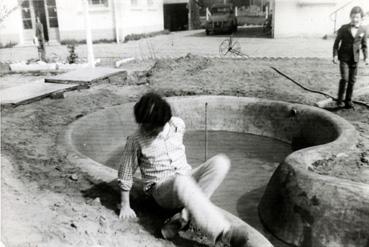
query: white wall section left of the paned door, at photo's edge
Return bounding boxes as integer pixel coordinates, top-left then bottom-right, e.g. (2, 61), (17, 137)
(0, 0), (23, 45)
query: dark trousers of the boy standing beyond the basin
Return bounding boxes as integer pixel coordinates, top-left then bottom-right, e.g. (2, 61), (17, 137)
(338, 61), (357, 103)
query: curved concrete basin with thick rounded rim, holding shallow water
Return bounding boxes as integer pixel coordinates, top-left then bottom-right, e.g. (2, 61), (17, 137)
(62, 96), (369, 247)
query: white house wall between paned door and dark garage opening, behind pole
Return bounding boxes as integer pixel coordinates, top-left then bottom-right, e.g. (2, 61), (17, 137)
(57, 0), (164, 40)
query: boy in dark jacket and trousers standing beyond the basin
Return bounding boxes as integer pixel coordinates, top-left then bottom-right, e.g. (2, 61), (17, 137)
(333, 7), (368, 108)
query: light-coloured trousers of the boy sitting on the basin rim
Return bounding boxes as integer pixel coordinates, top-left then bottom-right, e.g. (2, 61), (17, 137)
(152, 154), (230, 240)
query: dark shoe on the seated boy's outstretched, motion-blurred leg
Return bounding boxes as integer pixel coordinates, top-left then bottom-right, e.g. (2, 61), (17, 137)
(215, 226), (249, 247)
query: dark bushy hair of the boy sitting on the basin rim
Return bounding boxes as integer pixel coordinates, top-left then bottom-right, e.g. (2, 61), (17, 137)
(134, 93), (172, 131)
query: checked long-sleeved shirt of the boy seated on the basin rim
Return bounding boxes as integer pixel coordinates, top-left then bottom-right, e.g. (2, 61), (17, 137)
(118, 117), (191, 191)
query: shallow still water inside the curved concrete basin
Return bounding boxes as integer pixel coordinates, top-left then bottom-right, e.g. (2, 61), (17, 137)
(184, 131), (292, 247)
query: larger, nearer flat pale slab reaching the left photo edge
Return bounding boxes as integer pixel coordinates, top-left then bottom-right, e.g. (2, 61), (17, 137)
(0, 81), (79, 105)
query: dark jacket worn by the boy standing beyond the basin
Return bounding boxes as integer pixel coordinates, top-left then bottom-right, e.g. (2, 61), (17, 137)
(333, 24), (368, 63)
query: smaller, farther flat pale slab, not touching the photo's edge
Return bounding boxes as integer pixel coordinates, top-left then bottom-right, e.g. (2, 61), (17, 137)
(45, 67), (126, 84)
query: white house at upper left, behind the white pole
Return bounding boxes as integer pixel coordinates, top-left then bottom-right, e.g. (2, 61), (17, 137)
(0, 0), (164, 45)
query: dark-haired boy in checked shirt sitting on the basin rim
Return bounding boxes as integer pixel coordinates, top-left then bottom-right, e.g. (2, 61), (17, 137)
(118, 93), (248, 247)
